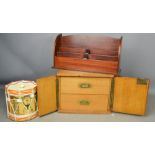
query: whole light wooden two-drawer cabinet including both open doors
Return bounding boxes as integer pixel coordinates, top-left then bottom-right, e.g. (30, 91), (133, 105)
(37, 70), (149, 116)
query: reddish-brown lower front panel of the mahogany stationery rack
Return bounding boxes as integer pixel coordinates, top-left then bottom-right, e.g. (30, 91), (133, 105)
(55, 56), (119, 75)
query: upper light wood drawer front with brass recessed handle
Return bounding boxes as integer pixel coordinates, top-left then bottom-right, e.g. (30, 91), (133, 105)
(60, 77), (111, 94)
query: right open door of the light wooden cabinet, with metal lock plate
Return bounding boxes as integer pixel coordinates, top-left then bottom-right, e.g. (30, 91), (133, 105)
(112, 77), (149, 115)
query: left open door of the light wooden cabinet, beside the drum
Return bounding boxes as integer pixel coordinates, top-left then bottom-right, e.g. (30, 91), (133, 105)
(37, 76), (57, 116)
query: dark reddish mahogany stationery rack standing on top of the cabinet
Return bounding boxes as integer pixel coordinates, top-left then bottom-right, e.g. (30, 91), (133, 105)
(54, 34), (122, 75)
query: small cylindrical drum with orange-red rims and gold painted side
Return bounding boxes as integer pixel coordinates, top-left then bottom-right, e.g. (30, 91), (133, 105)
(5, 81), (38, 121)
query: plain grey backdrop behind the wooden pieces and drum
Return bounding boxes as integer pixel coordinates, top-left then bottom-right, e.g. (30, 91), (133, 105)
(0, 33), (155, 93)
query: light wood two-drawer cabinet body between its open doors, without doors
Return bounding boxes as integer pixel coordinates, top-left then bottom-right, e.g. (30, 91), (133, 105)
(58, 71), (112, 113)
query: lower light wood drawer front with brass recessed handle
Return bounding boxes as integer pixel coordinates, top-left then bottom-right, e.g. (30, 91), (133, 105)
(59, 94), (109, 113)
